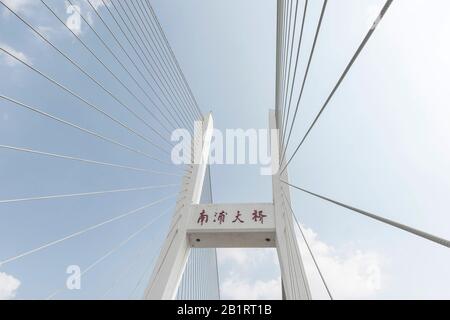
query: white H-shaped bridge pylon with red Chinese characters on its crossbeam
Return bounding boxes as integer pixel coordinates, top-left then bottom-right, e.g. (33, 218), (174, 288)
(144, 111), (311, 300)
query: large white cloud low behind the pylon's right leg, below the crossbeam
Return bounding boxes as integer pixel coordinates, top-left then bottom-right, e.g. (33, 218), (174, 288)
(218, 228), (385, 300)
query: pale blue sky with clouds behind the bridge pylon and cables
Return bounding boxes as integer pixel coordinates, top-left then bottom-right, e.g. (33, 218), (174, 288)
(0, 0), (450, 299)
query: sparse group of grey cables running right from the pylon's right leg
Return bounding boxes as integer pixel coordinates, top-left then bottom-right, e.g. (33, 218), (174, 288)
(270, 0), (450, 299)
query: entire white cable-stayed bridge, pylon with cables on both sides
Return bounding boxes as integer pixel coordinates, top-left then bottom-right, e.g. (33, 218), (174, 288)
(0, 0), (450, 300)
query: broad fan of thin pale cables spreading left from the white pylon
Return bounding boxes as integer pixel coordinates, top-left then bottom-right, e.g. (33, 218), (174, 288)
(0, 0), (204, 298)
